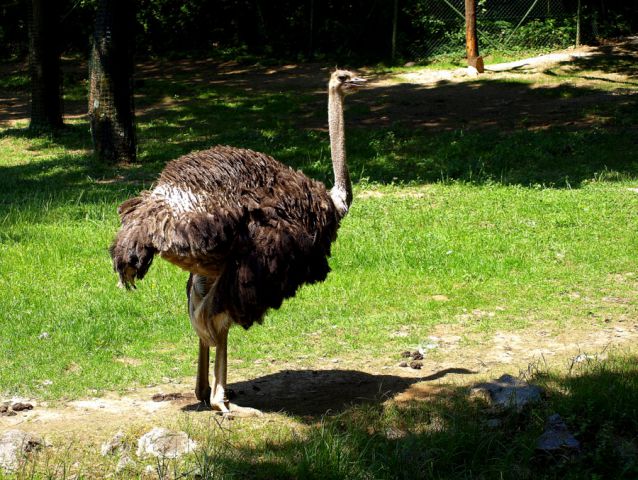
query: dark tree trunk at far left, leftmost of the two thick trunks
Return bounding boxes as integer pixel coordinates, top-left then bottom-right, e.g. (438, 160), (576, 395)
(29, 0), (62, 131)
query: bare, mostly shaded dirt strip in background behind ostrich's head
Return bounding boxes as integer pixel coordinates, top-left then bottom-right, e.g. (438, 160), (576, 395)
(0, 37), (638, 131)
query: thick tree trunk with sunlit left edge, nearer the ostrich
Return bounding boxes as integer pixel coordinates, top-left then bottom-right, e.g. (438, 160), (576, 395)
(89, 0), (135, 163)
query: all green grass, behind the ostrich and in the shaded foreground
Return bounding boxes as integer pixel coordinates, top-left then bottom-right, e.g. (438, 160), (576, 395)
(0, 43), (638, 478)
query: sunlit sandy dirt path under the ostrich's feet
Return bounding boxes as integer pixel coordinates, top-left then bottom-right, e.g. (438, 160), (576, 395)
(0, 319), (638, 444)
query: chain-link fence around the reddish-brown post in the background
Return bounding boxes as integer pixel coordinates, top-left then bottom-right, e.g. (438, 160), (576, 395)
(401, 0), (577, 61)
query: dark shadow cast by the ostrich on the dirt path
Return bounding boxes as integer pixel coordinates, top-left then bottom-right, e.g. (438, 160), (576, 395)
(182, 368), (476, 417)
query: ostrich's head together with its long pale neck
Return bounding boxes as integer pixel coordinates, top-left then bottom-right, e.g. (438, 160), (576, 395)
(328, 70), (365, 217)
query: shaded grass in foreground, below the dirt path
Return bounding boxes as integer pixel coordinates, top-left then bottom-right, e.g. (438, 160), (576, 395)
(6, 352), (638, 479)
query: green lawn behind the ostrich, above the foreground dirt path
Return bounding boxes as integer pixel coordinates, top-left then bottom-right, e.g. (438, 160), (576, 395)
(0, 50), (638, 398)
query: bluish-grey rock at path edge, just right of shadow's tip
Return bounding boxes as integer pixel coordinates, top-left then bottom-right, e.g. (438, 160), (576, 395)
(470, 374), (542, 412)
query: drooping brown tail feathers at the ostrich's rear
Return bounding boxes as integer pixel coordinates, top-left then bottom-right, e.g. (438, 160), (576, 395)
(109, 225), (156, 289)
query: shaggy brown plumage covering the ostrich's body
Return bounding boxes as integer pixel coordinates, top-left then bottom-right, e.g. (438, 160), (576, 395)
(111, 146), (339, 328)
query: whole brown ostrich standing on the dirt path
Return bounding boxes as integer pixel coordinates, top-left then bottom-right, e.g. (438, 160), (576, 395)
(109, 70), (365, 414)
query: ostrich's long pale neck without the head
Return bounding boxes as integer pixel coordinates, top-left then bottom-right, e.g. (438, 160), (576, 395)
(328, 88), (352, 215)
